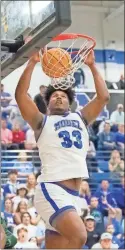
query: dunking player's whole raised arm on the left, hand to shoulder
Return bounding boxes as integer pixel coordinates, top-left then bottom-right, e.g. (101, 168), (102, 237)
(15, 53), (43, 130)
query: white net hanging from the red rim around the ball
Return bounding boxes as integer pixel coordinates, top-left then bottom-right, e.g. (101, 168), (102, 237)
(40, 34), (94, 90)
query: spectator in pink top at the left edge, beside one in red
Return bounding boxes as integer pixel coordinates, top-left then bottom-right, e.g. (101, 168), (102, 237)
(1, 120), (18, 149)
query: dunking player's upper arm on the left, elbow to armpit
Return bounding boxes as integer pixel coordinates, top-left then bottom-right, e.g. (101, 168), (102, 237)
(15, 93), (44, 131)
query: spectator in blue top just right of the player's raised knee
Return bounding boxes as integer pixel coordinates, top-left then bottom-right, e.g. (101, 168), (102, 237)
(89, 196), (105, 233)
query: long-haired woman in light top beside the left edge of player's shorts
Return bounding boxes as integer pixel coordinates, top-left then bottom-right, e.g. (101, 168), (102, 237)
(26, 174), (37, 204)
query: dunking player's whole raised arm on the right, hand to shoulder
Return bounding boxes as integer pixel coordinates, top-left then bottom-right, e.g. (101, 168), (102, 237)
(81, 50), (110, 124)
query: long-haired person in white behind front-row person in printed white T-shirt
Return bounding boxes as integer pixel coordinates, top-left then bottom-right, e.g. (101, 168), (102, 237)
(14, 212), (37, 240)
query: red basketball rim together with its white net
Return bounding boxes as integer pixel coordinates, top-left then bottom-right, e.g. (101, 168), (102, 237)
(40, 33), (96, 90)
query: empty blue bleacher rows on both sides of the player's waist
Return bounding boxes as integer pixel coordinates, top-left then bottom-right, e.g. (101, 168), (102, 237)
(1, 150), (120, 192)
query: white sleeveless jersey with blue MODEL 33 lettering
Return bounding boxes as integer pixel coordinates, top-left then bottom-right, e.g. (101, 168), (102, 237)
(37, 113), (89, 182)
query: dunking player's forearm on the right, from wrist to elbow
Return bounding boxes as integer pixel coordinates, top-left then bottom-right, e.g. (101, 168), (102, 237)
(90, 64), (110, 103)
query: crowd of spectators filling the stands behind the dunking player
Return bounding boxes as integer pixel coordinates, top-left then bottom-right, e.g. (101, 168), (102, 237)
(1, 84), (125, 249)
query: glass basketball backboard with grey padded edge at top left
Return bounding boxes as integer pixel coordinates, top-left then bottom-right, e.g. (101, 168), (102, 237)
(1, 0), (71, 79)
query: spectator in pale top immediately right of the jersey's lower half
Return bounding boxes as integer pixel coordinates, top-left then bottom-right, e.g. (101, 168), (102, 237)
(86, 141), (98, 173)
